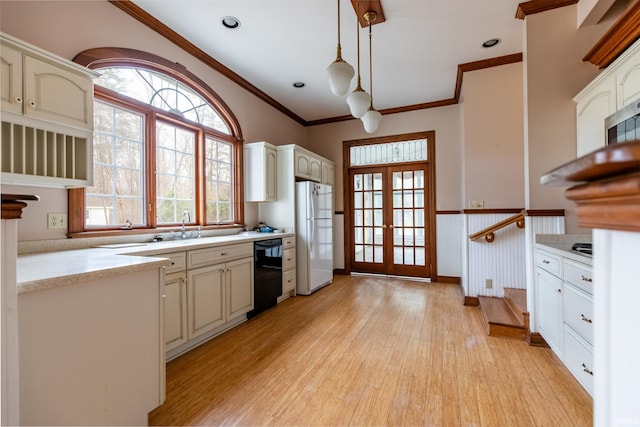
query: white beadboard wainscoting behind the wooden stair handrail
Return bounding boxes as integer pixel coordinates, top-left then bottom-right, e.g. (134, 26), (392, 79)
(463, 213), (526, 298)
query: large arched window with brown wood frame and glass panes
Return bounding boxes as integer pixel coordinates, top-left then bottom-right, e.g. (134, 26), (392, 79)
(69, 48), (243, 234)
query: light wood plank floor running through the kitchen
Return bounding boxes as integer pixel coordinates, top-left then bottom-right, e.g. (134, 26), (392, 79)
(149, 276), (593, 426)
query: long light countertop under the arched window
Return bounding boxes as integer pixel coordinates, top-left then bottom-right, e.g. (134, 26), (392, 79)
(16, 232), (293, 294)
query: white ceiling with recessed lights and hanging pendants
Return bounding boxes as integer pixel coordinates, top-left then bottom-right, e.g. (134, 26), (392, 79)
(133, 0), (524, 122)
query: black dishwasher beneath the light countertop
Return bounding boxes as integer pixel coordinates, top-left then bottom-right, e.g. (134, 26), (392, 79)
(247, 239), (282, 318)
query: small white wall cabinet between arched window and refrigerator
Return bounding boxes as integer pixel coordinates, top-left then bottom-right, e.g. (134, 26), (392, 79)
(244, 142), (278, 202)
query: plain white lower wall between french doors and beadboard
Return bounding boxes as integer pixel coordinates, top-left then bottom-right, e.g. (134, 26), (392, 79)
(436, 214), (462, 277)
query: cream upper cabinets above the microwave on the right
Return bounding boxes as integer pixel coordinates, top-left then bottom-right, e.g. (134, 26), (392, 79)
(573, 40), (640, 157)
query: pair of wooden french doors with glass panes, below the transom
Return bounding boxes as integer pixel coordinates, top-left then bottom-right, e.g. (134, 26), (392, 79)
(348, 162), (431, 277)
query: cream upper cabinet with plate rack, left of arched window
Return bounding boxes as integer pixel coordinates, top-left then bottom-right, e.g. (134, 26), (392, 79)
(0, 34), (96, 187)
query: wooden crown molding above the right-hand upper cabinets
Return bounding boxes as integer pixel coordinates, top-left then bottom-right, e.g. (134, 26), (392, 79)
(582, 0), (640, 69)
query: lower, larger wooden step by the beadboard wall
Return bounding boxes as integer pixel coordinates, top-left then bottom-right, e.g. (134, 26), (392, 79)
(478, 296), (527, 341)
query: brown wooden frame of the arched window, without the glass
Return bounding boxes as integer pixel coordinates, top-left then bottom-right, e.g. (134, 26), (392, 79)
(68, 48), (244, 241)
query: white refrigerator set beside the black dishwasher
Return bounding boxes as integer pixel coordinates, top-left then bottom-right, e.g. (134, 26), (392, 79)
(296, 181), (333, 295)
